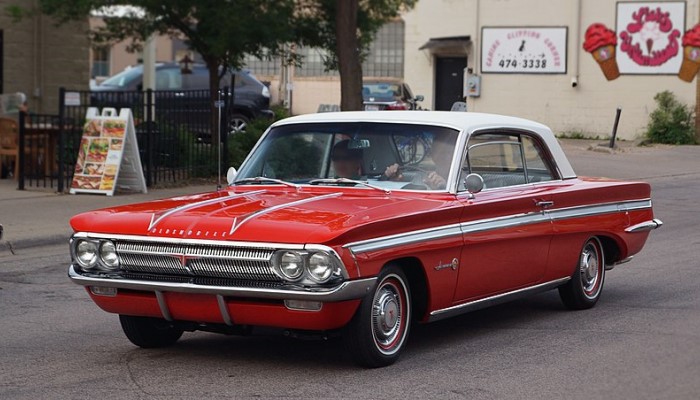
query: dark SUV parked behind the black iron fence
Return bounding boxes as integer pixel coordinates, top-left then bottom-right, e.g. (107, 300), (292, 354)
(92, 63), (273, 134)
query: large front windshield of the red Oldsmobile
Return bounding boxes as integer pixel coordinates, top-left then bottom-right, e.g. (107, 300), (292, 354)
(236, 122), (458, 190)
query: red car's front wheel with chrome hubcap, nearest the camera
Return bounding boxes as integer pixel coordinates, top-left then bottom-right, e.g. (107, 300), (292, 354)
(343, 266), (411, 368)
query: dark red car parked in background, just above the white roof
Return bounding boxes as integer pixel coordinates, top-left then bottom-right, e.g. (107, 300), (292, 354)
(362, 80), (423, 111)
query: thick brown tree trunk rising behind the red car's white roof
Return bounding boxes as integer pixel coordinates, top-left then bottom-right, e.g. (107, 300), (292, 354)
(335, 0), (362, 111)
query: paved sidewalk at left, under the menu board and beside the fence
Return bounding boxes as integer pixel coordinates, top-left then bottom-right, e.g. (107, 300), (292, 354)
(0, 179), (216, 251)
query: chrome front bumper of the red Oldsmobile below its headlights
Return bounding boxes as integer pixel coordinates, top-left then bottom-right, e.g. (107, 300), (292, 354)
(68, 265), (377, 302)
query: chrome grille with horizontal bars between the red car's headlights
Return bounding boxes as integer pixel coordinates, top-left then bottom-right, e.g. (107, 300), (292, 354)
(115, 240), (280, 281)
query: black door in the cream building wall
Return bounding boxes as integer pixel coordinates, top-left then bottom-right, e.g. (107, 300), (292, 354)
(435, 57), (467, 111)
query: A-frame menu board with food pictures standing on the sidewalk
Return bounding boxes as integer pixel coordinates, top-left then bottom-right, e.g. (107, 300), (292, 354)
(70, 108), (146, 196)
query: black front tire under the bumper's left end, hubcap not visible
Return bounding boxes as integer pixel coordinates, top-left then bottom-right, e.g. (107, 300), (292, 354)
(119, 315), (183, 349)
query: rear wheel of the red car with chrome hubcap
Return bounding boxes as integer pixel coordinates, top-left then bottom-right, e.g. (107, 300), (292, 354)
(559, 237), (605, 310)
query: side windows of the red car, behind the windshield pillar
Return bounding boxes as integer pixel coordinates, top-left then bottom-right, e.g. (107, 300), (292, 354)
(460, 133), (554, 189)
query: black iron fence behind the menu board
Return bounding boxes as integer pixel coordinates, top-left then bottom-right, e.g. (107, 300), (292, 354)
(18, 88), (232, 192)
